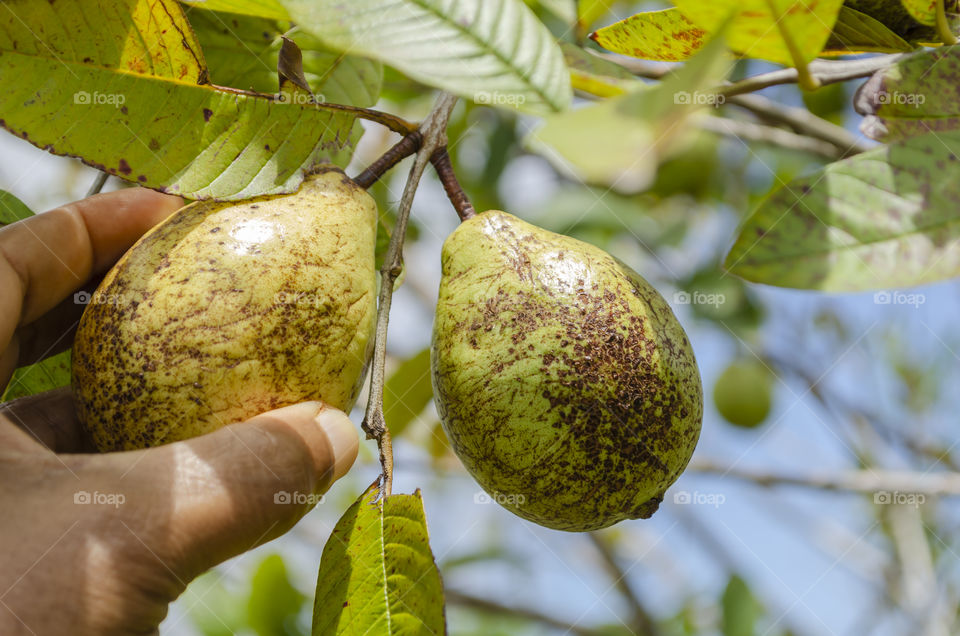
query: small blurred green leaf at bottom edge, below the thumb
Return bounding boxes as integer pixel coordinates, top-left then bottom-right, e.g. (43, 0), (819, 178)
(247, 554), (307, 636)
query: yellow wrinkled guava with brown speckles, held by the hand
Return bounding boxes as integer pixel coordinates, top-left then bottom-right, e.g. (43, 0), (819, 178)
(73, 167), (377, 451)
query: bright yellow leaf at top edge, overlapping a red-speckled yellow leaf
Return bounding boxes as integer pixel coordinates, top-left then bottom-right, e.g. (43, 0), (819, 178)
(674, 0), (843, 66)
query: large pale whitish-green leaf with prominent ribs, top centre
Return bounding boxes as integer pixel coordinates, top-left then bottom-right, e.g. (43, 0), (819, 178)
(281, 0), (571, 110)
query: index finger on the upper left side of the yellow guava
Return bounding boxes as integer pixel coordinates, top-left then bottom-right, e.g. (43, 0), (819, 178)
(0, 188), (183, 350)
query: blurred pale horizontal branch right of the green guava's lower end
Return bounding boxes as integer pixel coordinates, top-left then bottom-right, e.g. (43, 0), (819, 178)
(687, 460), (960, 497)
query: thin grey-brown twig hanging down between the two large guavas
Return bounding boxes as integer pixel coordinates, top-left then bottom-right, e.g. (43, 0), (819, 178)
(363, 92), (457, 497)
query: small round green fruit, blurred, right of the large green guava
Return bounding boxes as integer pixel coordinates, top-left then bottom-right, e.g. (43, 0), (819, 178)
(713, 358), (773, 428)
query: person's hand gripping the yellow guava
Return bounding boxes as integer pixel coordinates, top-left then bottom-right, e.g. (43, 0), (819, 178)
(0, 188), (358, 635)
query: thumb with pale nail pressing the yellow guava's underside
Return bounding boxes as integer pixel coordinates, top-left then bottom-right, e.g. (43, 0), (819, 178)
(113, 402), (359, 580)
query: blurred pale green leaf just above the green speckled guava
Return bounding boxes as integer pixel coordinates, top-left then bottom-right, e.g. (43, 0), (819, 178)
(526, 31), (730, 193)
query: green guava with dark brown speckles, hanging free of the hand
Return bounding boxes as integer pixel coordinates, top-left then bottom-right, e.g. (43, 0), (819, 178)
(431, 211), (703, 531)
